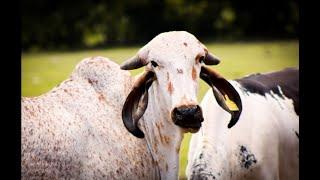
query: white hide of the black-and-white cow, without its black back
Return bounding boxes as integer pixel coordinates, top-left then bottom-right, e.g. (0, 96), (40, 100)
(186, 81), (299, 180)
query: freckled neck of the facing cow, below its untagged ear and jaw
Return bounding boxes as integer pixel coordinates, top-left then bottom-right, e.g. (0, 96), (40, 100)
(141, 83), (183, 180)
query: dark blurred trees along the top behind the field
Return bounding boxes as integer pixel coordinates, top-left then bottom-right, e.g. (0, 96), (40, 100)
(21, 0), (299, 50)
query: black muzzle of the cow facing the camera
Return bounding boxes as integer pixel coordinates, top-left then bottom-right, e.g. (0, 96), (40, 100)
(171, 105), (203, 130)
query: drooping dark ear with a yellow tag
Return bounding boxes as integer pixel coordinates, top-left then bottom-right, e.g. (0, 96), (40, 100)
(200, 66), (242, 128)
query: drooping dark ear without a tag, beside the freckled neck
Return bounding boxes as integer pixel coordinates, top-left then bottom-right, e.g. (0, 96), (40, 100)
(122, 71), (155, 138)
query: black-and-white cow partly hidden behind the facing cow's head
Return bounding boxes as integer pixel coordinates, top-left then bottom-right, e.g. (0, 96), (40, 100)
(186, 68), (299, 180)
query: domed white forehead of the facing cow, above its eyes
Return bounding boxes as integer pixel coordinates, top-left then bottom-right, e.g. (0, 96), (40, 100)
(147, 31), (205, 63)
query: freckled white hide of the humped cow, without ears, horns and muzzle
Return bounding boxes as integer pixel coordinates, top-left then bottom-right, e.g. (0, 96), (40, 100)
(21, 31), (212, 180)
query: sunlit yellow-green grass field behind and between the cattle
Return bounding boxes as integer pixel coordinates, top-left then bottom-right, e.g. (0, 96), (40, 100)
(21, 41), (299, 179)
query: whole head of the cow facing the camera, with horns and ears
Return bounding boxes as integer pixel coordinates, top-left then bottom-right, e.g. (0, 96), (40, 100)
(121, 32), (241, 138)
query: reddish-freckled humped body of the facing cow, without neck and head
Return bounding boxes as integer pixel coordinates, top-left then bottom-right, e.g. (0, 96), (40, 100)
(21, 57), (156, 179)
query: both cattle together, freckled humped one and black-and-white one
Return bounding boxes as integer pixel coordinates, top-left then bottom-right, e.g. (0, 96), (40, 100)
(21, 31), (299, 180)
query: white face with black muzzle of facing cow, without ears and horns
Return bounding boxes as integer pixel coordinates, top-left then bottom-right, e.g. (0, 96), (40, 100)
(146, 33), (211, 131)
